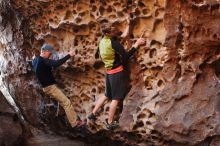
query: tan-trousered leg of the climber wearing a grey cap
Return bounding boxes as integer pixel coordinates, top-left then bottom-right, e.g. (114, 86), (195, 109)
(44, 85), (77, 127)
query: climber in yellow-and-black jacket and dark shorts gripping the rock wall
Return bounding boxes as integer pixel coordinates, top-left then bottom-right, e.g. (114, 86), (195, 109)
(88, 24), (145, 129)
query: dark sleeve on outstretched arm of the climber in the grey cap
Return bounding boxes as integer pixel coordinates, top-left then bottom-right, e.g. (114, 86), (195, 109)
(44, 54), (71, 67)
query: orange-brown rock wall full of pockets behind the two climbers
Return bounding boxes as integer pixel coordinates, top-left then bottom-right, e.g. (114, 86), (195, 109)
(0, 0), (220, 145)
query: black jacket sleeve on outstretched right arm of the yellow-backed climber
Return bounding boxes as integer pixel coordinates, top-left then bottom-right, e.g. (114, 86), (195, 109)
(111, 39), (136, 61)
